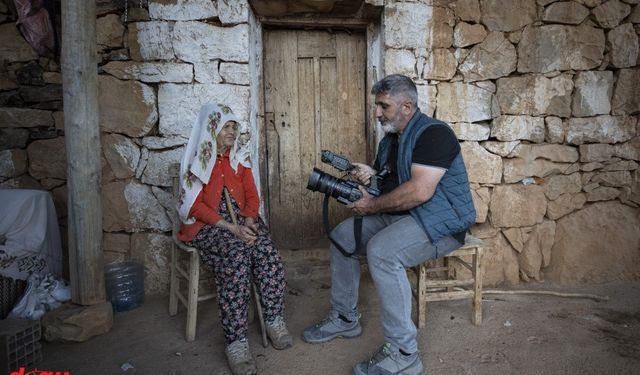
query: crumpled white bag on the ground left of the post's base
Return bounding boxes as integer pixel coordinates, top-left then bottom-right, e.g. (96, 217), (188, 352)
(9, 273), (71, 320)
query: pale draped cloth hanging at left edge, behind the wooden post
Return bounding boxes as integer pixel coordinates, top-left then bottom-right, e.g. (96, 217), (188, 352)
(0, 189), (62, 280)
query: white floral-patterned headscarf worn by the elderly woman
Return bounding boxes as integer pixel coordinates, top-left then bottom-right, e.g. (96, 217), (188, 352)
(177, 103), (251, 224)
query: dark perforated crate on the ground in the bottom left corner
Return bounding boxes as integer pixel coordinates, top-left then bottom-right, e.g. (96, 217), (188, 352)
(0, 319), (42, 375)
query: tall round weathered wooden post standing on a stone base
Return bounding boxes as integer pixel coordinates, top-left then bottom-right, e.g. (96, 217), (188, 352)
(61, 0), (105, 305)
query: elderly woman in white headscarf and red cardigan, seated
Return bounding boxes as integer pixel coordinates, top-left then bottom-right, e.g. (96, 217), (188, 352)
(178, 104), (292, 375)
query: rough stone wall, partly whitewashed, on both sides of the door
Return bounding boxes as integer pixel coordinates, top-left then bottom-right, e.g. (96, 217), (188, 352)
(0, 0), (640, 293)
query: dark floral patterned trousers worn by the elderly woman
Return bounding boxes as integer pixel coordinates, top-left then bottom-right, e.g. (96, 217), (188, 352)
(192, 196), (285, 345)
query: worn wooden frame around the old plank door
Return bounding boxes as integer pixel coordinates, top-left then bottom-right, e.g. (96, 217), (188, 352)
(249, 17), (384, 222)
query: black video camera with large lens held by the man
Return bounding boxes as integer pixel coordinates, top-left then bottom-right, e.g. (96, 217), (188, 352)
(307, 150), (389, 204)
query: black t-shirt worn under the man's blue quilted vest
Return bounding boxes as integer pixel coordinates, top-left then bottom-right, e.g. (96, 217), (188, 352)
(373, 125), (465, 243)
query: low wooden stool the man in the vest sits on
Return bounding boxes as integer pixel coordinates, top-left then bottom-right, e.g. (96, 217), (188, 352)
(413, 235), (484, 328)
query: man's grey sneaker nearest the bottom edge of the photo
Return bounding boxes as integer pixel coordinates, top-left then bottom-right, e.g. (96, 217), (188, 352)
(352, 343), (422, 375)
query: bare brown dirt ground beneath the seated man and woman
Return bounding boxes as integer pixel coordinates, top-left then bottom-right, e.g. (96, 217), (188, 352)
(38, 274), (640, 375)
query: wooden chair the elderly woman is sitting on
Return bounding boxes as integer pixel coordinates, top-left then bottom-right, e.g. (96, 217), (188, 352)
(169, 164), (269, 348)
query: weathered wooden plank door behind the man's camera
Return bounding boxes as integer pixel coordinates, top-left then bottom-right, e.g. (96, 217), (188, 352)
(264, 30), (367, 249)
